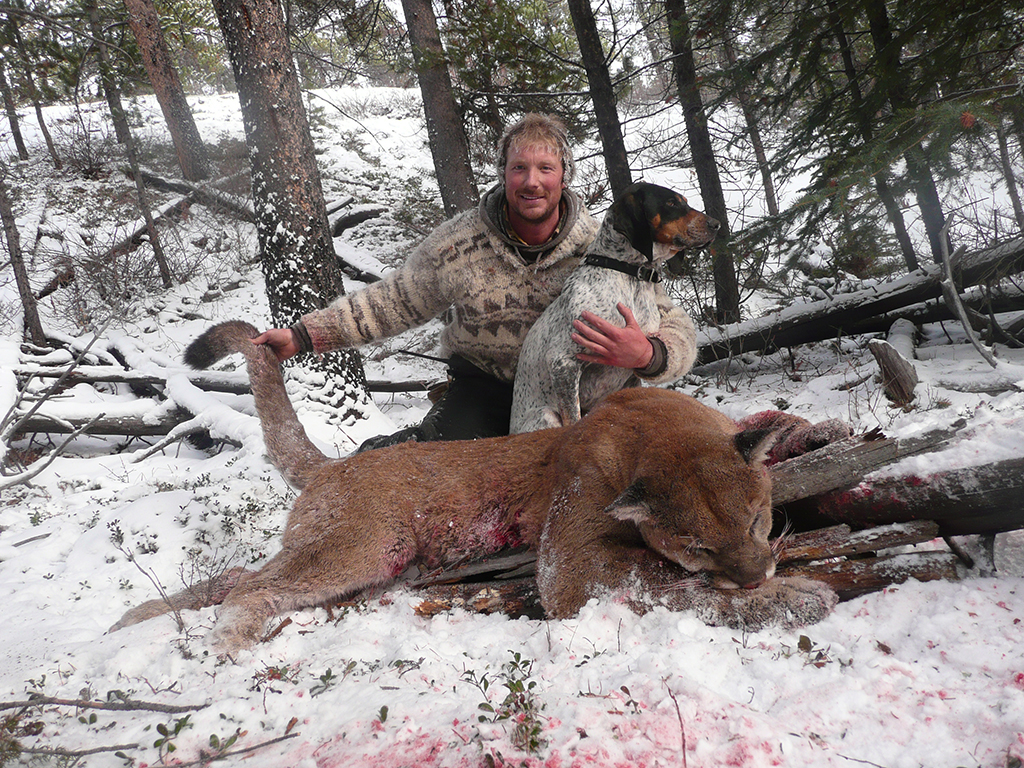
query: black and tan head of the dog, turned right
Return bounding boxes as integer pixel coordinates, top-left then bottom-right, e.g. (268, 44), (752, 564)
(607, 181), (721, 261)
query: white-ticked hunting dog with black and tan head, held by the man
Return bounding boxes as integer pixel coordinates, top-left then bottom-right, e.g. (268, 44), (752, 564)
(510, 181), (721, 434)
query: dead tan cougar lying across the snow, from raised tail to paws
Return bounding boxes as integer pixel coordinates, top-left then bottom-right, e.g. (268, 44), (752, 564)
(117, 322), (836, 651)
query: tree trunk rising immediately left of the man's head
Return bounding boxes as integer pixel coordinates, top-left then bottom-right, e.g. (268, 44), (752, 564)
(401, 0), (479, 216)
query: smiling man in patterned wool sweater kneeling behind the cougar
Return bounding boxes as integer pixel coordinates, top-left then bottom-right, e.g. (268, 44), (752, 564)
(253, 114), (696, 451)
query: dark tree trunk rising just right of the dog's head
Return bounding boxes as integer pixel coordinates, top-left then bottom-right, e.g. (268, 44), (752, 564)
(665, 0), (739, 323)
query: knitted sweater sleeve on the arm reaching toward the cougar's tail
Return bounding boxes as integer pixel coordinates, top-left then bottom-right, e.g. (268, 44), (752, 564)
(302, 225), (452, 353)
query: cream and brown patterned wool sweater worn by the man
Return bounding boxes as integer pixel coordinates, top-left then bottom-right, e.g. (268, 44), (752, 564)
(302, 185), (696, 382)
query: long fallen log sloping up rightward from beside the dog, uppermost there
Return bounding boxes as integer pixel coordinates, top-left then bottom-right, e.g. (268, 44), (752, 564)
(698, 238), (1024, 365)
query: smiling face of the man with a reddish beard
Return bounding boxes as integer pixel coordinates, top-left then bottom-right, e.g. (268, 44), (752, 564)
(505, 146), (563, 236)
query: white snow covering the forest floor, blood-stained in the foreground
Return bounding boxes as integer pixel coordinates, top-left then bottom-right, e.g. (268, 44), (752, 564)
(0, 89), (1024, 768)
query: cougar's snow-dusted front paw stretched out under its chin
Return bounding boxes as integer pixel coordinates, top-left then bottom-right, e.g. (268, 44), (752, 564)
(695, 578), (839, 632)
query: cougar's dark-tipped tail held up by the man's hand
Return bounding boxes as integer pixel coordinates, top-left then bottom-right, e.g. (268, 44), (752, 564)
(184, 321), (330, 490)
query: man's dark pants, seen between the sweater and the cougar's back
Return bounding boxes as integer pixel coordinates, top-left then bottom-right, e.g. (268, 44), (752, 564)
(356, 354), (512, 453)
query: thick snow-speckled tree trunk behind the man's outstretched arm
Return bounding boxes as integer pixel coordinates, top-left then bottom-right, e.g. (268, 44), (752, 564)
(213, 0), (367, 419)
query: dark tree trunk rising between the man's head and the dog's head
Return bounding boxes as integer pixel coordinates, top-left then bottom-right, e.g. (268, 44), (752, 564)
(568, 0), (632, 199)
